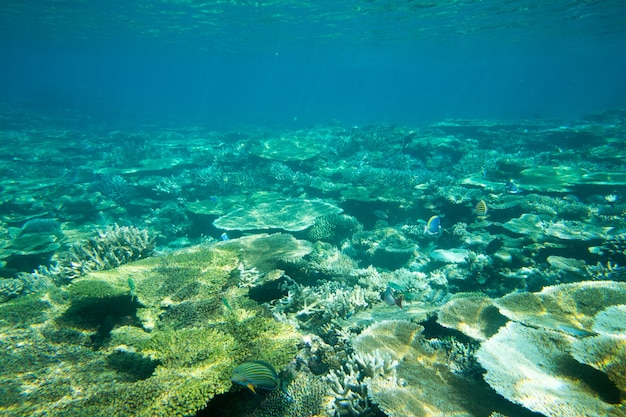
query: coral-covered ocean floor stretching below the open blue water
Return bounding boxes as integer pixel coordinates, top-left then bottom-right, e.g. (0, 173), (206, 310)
(0, 110), (626, 417)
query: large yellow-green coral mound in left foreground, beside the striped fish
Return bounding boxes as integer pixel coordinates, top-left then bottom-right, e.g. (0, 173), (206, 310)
(0, 240), (299, 416)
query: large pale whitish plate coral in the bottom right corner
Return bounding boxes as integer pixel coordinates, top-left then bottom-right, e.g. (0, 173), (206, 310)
(477, 322), (624, 417)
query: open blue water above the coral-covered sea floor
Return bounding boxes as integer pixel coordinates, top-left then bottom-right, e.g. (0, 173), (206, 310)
(0, 0), (626, 128)
